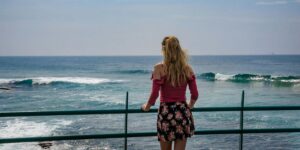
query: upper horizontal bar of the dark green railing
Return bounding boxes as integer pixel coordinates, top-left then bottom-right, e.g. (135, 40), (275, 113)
(0, 106), (300, 117)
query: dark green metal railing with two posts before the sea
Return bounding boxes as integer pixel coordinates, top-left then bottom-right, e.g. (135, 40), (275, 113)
(0, 91), (300, 150)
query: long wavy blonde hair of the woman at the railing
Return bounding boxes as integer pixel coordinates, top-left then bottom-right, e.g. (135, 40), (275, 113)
(162, 36), (191, 87)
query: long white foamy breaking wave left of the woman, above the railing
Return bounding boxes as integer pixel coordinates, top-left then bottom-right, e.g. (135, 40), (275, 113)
(0, 77), (126, 85)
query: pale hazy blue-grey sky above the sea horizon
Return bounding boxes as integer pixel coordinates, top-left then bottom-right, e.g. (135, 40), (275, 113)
(0, 0), (300, 56)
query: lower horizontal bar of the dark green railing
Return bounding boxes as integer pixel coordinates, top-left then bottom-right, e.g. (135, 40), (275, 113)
(0, 128), (300, 144)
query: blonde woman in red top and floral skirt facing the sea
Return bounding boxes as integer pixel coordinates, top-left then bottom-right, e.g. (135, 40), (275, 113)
(142, 36), (198, 150)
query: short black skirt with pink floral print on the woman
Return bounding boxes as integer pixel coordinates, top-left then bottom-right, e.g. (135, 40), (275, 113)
(157, 101), (195, 142)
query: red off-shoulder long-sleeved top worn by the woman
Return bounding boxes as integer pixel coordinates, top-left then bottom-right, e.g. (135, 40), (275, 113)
(148, 63), (198, 105)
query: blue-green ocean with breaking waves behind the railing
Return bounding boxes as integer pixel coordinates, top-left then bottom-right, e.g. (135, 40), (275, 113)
(0, 55), (300, 150)
